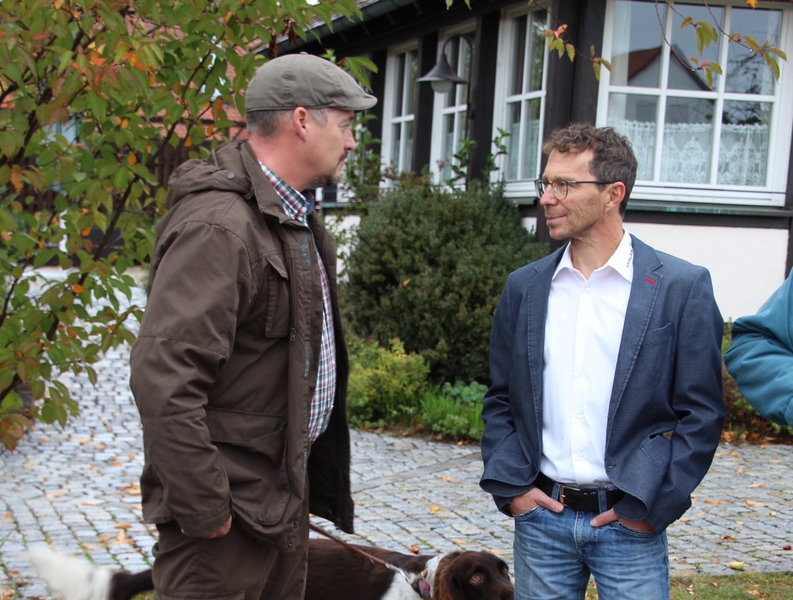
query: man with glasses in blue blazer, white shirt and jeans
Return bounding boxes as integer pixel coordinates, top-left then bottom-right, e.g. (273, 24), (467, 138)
(480, 124), (725, 600)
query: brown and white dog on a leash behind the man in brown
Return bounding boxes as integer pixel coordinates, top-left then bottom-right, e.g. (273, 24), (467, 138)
(29, 538), (513, 600)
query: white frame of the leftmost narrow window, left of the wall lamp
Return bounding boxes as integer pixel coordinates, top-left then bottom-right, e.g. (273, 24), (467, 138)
(381, 40), (420, 172)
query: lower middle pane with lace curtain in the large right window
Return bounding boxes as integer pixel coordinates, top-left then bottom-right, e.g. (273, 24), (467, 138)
(661, 98), (714, 183)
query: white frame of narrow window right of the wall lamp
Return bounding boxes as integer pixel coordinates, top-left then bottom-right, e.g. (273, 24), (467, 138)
(490, 7), (549, 198)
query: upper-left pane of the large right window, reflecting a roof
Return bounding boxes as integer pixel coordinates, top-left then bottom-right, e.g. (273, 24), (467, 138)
(611, 0), (666, 87)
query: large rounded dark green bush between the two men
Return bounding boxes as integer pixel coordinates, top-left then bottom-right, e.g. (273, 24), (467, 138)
(342, 179), (547, 381)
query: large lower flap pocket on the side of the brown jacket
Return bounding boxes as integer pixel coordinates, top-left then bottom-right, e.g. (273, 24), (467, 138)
(206, 407), (292, 525)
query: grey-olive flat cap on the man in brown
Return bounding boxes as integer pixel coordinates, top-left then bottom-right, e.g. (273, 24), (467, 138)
(245, 52), (377, 112)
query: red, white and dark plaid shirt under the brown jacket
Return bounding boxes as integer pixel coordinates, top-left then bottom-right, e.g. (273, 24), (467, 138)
(259, 162), (336, 444)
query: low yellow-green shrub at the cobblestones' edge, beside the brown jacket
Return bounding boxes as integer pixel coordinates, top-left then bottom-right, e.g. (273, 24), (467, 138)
(347, 337), (429, 427)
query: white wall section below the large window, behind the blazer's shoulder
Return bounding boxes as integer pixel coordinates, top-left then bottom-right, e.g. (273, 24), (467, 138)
(625, 223), (788, 321)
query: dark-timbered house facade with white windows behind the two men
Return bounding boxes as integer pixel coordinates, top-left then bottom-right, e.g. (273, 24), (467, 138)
(281, 0), (793, 320)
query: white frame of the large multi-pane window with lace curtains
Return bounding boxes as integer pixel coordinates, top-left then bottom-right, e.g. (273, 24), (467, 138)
(597, 0), (793, 206)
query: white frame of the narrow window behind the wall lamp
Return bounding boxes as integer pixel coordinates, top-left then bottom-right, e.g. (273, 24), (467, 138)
(430, 21), (476, 187)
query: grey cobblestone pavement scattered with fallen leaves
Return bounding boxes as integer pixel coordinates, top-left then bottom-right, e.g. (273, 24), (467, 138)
(0, 272), (793, 599)
